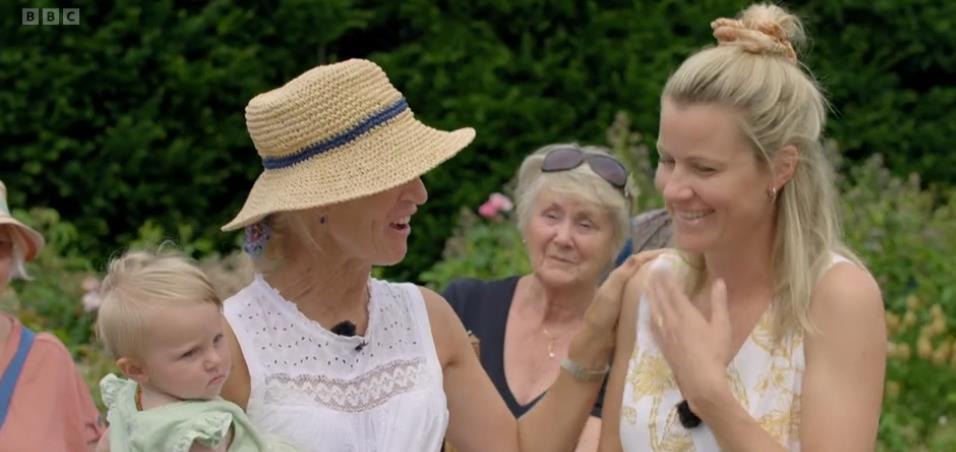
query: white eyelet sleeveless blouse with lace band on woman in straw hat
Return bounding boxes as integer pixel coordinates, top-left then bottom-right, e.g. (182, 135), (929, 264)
(224, 275), (448, 452)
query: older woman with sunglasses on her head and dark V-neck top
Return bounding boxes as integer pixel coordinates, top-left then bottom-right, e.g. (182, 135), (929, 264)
(442, 144), (648, 451)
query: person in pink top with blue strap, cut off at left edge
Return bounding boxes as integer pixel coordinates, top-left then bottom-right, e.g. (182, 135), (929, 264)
(0, 182), (102, 451)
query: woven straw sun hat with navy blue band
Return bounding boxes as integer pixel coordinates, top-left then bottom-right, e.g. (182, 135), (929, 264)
(222, 60), (475, 231)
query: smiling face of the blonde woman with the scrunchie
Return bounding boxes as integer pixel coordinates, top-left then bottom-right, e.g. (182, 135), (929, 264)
(654, 99), (773, 253)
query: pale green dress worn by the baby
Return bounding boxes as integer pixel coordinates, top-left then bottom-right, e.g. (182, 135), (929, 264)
(100, 374), (296, 452)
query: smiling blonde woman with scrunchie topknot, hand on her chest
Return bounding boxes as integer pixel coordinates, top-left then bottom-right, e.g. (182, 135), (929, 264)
(601, 4), (886, 452)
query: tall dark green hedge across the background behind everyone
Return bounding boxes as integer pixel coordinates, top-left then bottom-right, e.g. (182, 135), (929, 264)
(0, 0), (956, 278)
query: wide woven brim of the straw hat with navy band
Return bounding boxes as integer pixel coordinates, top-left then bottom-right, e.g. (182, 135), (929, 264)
(222, 113), (475, 231)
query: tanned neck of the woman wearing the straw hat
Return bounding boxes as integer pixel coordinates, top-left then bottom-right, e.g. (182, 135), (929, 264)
(263, 246), (372, 335)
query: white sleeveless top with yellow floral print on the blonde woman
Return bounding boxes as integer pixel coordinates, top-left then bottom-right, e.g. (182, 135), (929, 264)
(620, 255), (849, 452)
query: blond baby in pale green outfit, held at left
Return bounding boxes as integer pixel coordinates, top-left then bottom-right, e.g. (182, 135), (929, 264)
(96, 251), (294, 452)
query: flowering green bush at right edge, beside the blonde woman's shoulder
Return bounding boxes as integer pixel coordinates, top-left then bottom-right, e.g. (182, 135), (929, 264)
(843, 156), (956, 450)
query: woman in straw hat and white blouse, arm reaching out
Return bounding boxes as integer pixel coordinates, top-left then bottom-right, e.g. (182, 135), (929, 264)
(223, 60), (639, 451)
